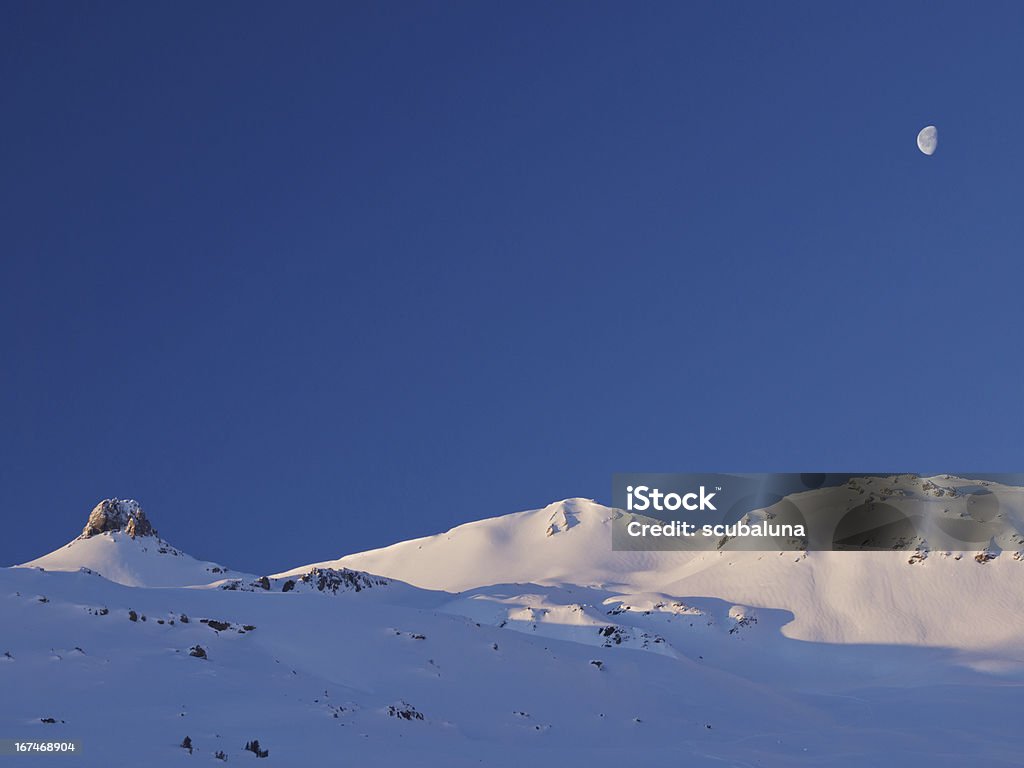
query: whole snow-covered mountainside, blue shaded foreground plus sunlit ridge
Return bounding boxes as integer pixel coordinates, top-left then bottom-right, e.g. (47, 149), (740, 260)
(0, 483), (1024, 768)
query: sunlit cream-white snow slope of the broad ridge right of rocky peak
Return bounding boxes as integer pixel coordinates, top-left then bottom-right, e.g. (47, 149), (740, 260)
(297, 480), (1024, 662)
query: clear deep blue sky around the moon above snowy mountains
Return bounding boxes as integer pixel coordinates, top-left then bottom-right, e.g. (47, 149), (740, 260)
(0, 2), (1024, 572)
